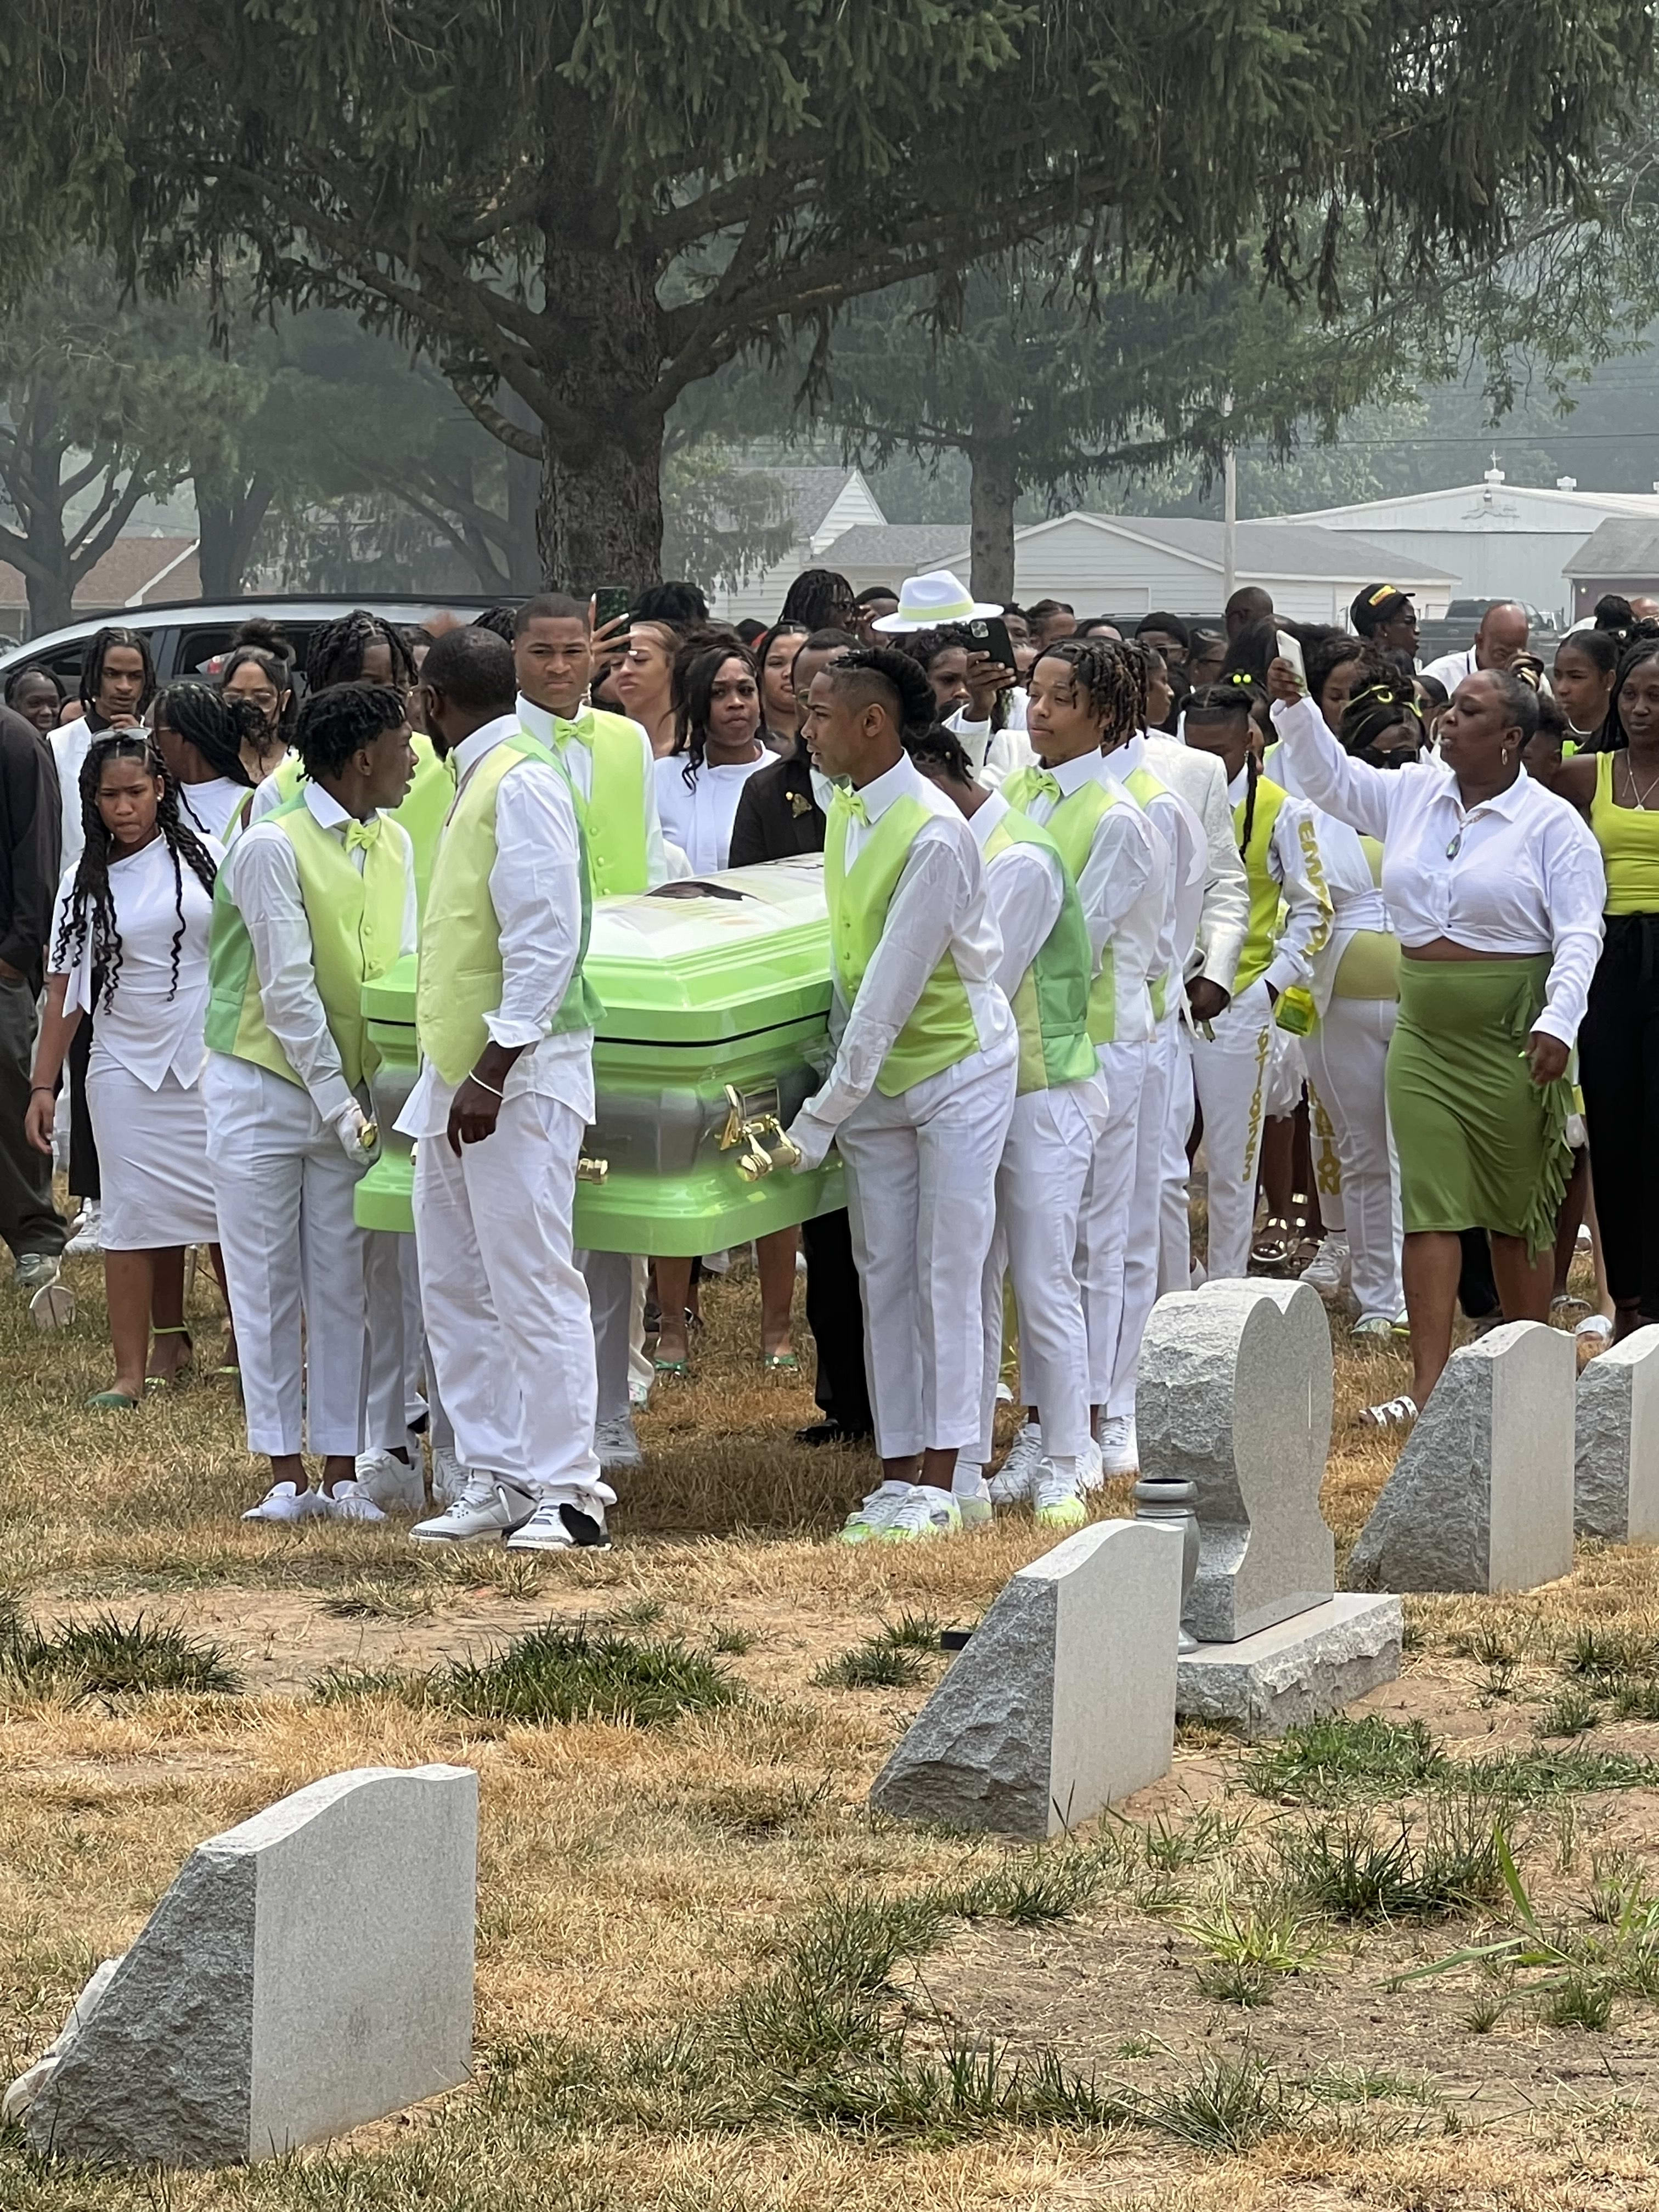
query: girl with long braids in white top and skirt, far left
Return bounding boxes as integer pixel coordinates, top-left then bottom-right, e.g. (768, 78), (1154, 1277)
(24, 730), (223, 1411)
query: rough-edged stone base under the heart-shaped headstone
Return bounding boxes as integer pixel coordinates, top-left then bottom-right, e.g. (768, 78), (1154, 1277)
(1175, 1593), (1402, 1736)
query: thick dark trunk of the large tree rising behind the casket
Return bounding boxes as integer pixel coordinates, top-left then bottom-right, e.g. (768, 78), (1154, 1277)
(535, 236), (664, 600)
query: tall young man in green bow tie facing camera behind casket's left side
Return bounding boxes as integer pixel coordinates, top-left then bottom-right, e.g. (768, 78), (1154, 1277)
(513, 591), (670, 1466)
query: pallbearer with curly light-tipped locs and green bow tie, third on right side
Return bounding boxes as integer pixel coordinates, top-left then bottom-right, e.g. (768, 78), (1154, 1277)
(991, 637), (1172, 1502)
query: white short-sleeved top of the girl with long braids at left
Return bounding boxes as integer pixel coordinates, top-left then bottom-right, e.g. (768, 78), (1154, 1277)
(47, 836), (223, 1091)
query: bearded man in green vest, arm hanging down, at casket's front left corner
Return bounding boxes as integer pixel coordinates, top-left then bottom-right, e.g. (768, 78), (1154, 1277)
(398, 628), (617, 1550)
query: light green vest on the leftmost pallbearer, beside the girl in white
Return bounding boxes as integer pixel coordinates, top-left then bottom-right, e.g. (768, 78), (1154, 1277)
(206, 796), (409, 1091)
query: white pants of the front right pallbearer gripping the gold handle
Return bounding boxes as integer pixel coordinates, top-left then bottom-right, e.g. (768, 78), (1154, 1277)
(836, 1031), (1018, 1460)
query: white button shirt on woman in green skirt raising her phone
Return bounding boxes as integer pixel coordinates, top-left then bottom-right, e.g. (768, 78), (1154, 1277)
(1272, 699), (1606, 1044)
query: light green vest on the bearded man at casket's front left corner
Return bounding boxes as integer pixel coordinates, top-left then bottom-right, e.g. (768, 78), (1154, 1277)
(416, 730), (604, 1084)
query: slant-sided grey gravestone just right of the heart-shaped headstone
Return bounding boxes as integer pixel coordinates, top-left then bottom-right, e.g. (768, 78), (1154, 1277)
(1350, 1321), (1577, 1590)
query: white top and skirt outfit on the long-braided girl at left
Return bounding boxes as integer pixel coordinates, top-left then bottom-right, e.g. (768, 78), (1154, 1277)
(49, 838), (223, 1252)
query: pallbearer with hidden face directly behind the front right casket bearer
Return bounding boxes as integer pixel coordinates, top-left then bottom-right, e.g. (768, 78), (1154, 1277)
(905, 728), (1108, 1528)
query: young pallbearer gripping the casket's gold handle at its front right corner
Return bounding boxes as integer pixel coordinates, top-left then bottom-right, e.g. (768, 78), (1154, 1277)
(789, 650), (1020, 1542)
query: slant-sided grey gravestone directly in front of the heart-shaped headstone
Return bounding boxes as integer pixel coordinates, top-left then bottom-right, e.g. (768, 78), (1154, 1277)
(870, 1522), (1181, 1838)
